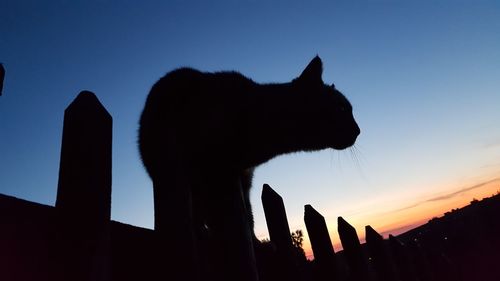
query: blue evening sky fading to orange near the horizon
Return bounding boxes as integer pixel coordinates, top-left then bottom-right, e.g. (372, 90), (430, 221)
(0, 0), (500, 254)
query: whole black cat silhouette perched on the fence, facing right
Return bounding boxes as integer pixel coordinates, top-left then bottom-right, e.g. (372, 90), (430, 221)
(138, 56), (360, 276)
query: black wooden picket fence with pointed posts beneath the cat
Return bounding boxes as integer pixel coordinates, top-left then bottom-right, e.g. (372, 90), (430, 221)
(0, 91), (498, 281)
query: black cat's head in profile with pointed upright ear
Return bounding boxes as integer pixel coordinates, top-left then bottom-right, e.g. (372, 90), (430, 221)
(292, 56), (360, 150)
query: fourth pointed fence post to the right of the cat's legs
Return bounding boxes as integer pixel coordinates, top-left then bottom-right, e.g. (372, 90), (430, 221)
(365, 225), (396, 281)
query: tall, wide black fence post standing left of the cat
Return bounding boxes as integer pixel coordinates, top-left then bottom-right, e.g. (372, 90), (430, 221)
(56, 91), (113, 280)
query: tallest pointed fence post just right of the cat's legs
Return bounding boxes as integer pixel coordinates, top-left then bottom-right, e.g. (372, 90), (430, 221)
(261, 184), (299, 280)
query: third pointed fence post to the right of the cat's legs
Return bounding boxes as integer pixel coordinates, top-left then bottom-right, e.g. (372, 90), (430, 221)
(337, 217), (370, 281)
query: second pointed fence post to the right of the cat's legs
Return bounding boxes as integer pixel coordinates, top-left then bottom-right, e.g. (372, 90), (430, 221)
(304, 205), (337, 280)
